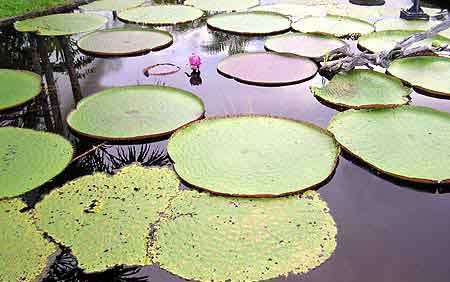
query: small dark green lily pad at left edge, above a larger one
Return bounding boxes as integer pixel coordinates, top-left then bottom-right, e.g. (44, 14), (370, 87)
(0, 69), (42, 111)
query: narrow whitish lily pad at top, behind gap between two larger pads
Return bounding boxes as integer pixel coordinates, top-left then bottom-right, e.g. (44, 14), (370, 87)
(251, 4), (326, 18)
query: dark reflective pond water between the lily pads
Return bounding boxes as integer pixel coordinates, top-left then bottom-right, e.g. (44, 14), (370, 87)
(0, 0), (450, 282)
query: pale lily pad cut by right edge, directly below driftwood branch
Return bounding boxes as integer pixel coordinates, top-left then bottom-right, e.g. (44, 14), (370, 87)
(387, 56), (450, 96)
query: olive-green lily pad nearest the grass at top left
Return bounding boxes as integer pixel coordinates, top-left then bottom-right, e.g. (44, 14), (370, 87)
(14, 14), (108, 36)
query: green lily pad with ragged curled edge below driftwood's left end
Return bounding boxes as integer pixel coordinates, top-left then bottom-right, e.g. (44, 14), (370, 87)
(311, 69), (411, 109)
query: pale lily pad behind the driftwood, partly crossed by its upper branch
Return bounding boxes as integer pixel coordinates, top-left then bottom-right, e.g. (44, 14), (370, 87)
(358, 30), (450, 53)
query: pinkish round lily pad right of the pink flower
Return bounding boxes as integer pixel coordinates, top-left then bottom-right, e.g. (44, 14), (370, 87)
(217, 52), (318, 86)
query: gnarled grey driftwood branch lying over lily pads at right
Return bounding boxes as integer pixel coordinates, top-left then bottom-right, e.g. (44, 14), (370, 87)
(321, 16), (450, 73)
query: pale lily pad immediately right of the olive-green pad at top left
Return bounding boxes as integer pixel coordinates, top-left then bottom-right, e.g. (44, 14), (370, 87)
(118, 5), (203, 25)
